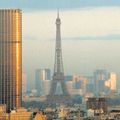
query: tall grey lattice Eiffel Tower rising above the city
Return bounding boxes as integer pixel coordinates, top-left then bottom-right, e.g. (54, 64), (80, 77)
(47, 11), (72, 104)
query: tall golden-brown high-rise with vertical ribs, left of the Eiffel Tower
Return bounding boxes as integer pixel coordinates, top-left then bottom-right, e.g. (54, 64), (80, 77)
(0, 9), (22, 111)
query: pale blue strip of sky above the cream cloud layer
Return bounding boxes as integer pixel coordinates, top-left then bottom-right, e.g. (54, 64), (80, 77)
(0, 0), (120, 9)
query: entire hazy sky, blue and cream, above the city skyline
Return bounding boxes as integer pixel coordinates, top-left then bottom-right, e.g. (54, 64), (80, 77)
(0, 0), (120, 89)
